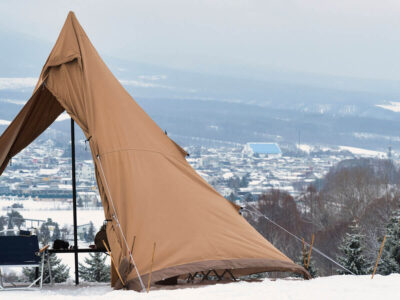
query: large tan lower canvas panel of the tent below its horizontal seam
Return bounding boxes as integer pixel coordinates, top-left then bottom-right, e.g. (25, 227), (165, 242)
(98, 151), (291, 276)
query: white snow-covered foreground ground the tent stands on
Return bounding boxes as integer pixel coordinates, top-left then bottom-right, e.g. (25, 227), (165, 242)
(0, 274), (400, 300)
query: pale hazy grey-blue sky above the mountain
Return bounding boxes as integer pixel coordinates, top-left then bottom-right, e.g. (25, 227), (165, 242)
(0, 0), (400, 80)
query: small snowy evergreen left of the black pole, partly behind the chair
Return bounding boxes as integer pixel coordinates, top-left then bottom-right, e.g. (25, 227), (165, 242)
(22, 253), (69, 283)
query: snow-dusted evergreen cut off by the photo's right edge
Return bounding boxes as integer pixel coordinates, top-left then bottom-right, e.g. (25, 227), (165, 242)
(376, 209), (400, 275)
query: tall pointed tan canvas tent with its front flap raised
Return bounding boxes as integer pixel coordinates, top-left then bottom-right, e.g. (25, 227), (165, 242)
(0, 12), (309, 290)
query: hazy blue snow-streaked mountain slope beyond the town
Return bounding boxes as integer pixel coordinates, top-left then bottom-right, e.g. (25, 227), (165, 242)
(0, 31), (400, 150)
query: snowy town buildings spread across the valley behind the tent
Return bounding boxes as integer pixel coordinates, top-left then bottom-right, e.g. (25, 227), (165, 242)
(0, 140), (376, 207)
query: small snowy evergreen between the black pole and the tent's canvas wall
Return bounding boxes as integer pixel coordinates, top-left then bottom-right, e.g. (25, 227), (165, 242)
(79, 252), (110, 282)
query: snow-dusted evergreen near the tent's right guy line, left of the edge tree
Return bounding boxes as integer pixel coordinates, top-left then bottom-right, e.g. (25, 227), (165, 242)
(337, 223), (371, 275)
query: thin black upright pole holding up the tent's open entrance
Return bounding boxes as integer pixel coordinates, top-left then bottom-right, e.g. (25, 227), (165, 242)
(71, 118), (79, 285)
